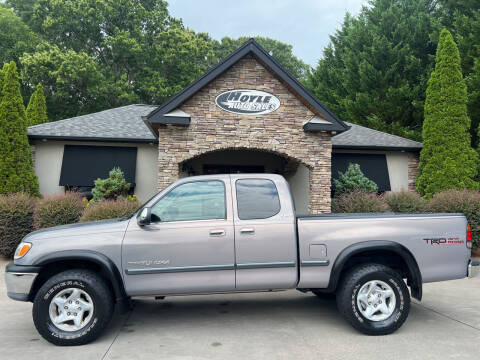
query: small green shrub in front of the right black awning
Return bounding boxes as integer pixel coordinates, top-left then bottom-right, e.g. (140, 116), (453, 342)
(333, 164), (378, 196)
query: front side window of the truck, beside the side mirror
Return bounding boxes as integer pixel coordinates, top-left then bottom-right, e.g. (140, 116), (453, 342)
(152, 180), (226, 222)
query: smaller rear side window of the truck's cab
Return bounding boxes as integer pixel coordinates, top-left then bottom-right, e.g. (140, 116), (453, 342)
(235, 179), (280, 220)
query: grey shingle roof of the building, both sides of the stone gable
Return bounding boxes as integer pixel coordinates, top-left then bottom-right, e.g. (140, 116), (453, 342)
(28, 105), (422, 150)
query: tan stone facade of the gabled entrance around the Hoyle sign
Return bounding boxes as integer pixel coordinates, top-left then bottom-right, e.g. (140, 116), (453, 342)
(158, 56), (332, 214)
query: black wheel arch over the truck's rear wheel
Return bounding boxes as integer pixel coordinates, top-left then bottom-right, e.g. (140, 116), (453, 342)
(327, 240), (422, 300)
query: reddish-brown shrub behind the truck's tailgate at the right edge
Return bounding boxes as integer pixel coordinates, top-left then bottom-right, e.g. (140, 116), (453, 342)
(428, 190), (480, 248)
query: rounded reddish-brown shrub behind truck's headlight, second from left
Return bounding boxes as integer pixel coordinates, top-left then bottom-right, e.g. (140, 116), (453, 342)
(33, 192), (85, 229)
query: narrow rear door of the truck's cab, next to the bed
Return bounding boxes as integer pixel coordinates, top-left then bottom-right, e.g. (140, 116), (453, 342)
(231, 175), (297, 290)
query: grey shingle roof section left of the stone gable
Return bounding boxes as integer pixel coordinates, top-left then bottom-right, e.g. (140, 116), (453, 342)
(28, 104), (157, 142)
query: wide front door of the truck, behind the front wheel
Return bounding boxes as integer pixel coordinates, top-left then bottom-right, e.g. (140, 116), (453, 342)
(122, 176), (235, 295)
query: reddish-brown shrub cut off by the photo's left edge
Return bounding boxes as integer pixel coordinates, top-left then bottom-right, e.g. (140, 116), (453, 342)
(0, 193), (35, 257)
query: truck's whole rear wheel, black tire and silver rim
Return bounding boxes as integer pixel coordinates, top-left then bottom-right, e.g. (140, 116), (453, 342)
(337, 264), (410, 335)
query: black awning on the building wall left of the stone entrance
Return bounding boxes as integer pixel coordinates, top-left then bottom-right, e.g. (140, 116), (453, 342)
(59, 145), (137, 186)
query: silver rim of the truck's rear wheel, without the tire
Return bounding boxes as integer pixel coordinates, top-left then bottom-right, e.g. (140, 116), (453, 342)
(357, 280), (397, 321)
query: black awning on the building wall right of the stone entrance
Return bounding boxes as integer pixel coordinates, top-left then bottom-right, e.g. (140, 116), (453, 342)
(332, 153), (391, 191)
